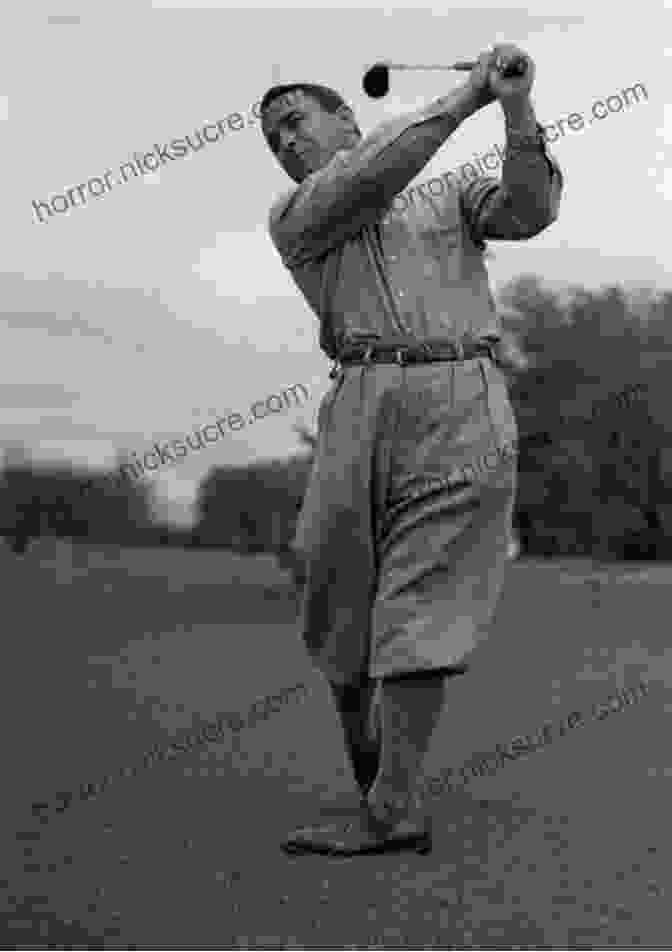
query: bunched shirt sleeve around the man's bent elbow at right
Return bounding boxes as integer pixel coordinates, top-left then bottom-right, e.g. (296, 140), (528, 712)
(460, 130), (564, 247)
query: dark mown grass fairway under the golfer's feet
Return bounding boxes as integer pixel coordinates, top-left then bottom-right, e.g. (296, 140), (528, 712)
(0, 540), (672, 949)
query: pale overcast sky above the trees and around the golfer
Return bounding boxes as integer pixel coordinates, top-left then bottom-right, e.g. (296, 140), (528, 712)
(0, 0), (672, 520)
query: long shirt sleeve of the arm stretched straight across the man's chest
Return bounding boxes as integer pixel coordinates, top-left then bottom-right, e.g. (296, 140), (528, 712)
(269, 95), (478, 268)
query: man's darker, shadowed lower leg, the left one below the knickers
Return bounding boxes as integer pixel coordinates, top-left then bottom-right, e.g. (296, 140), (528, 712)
(329, 678), (380, 796)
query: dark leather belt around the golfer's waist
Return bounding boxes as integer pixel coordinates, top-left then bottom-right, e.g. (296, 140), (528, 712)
(329, 340), (496, 378)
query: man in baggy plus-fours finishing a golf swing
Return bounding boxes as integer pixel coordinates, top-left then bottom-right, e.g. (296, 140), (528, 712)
(261, 44), (562, 855)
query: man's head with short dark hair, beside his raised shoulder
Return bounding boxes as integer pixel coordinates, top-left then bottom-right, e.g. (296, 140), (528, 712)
(262, 89), (360, 182)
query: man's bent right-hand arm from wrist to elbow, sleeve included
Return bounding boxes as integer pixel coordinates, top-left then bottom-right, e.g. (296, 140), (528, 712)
(462, 97), (563, 243)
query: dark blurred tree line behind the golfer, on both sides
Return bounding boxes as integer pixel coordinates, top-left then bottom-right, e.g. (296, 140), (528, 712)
(0, 275), (672, 568)
